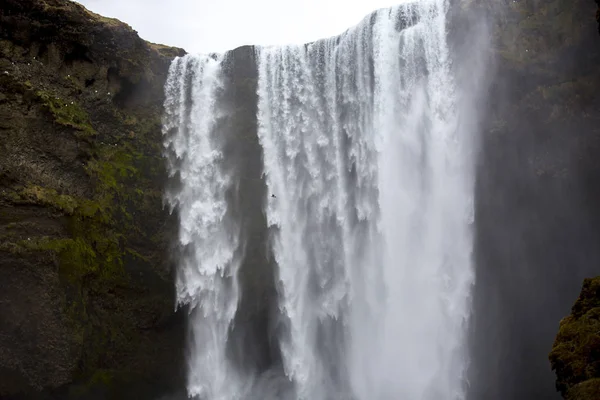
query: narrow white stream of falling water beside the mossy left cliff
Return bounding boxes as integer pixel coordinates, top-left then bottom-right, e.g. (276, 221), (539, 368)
(163, 56), (240, 400)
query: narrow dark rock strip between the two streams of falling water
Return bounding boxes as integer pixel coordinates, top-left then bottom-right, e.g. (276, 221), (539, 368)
(224, 46), (280, 374)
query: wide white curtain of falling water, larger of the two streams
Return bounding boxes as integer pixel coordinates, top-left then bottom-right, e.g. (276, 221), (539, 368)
(257, 0), (474, 400)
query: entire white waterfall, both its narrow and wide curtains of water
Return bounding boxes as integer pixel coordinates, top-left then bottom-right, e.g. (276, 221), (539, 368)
(164, 0), (474, 400)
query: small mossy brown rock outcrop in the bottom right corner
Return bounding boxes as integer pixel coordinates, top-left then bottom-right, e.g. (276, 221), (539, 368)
(550, 277), (600, 400)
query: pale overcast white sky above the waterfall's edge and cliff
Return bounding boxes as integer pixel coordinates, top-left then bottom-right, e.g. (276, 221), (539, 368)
(78, 0), (405, 53)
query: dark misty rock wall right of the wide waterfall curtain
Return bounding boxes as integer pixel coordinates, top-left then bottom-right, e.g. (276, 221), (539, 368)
(469, 0), (600, 400)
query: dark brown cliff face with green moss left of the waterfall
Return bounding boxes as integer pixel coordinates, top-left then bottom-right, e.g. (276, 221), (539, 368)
(0, 0), (184, 398)
